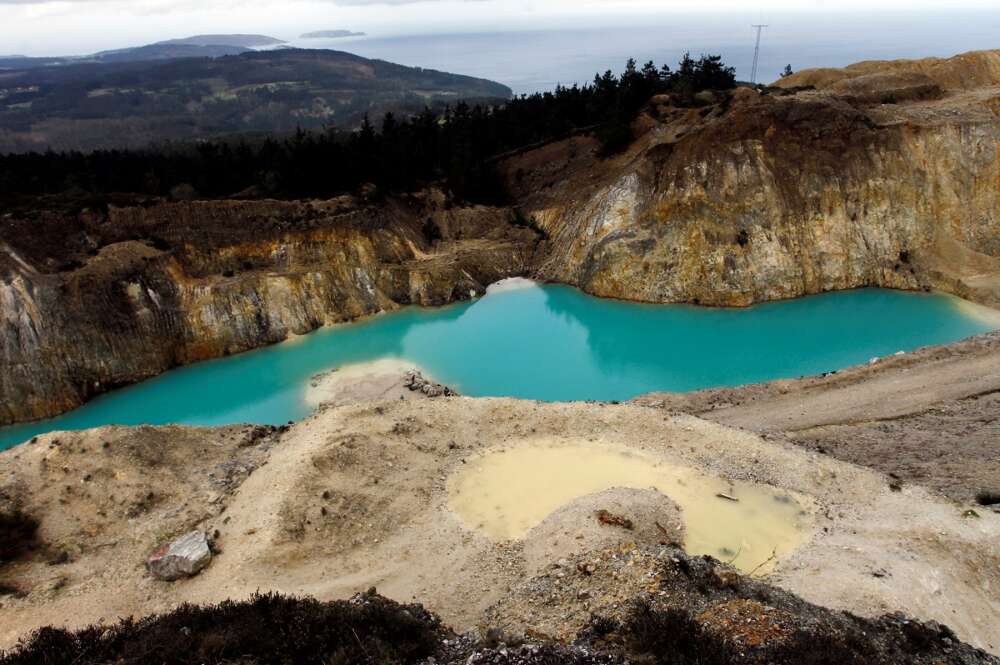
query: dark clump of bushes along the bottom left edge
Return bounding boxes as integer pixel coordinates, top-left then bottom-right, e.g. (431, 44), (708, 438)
(0, 590), (445, 665)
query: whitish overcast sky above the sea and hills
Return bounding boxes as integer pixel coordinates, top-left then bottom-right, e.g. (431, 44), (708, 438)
(0, 0), (1000, 55)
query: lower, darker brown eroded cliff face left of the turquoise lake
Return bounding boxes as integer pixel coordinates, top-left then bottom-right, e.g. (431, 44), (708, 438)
(0, 195), (537, 424)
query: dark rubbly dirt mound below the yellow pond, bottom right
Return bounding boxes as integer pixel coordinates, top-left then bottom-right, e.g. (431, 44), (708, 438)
(489, 547), (1000, 665)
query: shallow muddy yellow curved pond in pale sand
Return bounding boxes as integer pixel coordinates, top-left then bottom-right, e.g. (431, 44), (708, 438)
(449, 441), (813, 573)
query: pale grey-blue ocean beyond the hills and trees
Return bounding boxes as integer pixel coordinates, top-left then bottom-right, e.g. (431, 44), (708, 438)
(291, 11), (1000, 94)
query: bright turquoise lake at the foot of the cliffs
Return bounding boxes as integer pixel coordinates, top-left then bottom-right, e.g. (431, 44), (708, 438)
(0, 286), (992, 449)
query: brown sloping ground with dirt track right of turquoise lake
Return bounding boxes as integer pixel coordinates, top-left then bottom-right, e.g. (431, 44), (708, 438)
(637, 333), (1000, 503)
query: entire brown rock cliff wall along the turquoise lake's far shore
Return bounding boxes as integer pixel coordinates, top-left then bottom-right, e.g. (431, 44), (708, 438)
(0, 52), (1000, 424)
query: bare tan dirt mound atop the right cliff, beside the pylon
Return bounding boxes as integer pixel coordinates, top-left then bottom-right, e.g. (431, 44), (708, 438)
(773, 50), (1000, 94)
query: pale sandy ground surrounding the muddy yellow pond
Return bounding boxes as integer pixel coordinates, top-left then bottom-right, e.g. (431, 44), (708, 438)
(0, 378), (1000, 653)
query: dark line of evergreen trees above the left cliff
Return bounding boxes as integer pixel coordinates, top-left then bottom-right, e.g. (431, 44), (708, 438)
(0, 55), (736, 203)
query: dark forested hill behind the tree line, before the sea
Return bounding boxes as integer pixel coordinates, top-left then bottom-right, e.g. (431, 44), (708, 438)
(0, 49), (511, 153)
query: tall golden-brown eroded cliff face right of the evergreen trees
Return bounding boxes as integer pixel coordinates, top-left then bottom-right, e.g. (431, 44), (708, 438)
(507, 57), (1000, 306)
